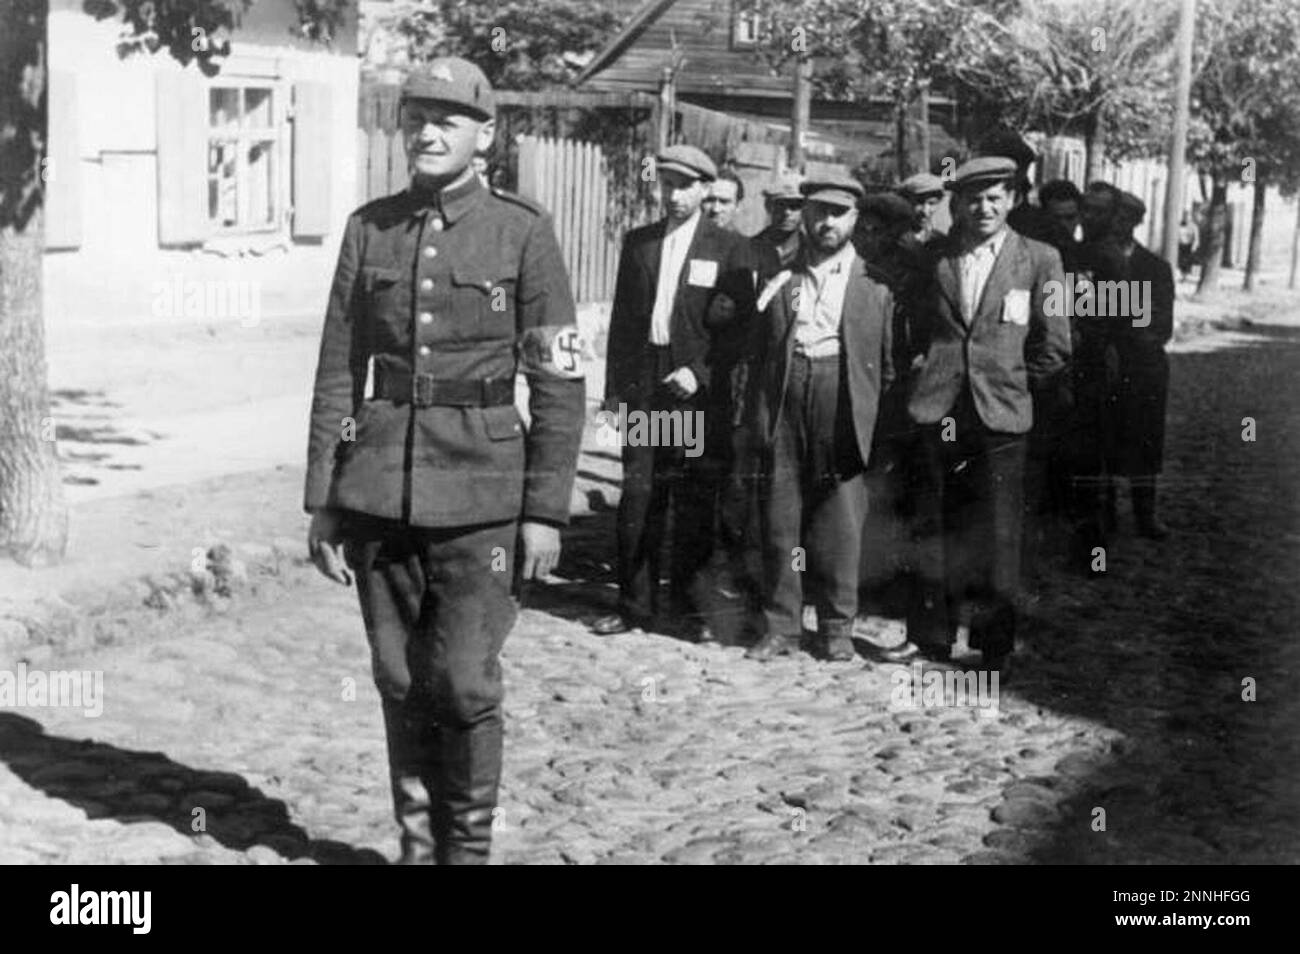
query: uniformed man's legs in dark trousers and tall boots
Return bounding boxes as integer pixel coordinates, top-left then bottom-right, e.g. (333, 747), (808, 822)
(345, 513), (517, 864)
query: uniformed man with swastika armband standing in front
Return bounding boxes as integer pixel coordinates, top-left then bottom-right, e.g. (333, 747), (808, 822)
(306, 57), (585, 864)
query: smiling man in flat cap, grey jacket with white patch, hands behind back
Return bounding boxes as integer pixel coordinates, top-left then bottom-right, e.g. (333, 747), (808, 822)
(889, 157), (1070, 668)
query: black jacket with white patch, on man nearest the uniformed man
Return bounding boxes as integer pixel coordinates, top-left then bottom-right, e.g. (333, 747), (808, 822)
(605, 214), (754, 406)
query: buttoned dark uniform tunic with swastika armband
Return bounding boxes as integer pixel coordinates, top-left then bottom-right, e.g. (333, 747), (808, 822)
(304, 177), (585, 528)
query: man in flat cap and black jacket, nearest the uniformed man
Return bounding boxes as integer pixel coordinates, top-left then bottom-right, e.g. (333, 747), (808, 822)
(592, 146), (753, 641)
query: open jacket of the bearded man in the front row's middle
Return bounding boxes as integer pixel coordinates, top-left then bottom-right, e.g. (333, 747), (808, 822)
(749, 255), (894, 464)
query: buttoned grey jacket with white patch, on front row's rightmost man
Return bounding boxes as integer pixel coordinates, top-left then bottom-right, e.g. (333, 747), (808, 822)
(907, 229), (1070, 434)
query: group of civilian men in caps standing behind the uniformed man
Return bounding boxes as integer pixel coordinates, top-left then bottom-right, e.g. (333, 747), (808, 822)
(593, 146), (1174, 677)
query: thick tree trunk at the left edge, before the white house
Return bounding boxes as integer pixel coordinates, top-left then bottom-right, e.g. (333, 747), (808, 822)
(0, 0), (68, 565)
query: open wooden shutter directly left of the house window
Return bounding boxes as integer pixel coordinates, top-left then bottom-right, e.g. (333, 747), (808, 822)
(156, 69), (212, 246)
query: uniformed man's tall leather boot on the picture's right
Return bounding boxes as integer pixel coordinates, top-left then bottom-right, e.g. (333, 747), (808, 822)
(434, 715), (502, 864)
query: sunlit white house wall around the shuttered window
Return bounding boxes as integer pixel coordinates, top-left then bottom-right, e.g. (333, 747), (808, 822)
(44, 10), (358, 346)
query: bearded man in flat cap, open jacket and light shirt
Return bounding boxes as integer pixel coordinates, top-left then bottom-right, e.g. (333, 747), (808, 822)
(749, 175), (894, 660)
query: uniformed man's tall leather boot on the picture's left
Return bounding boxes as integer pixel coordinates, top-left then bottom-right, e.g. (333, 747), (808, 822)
(384, 699), (438, 864)
